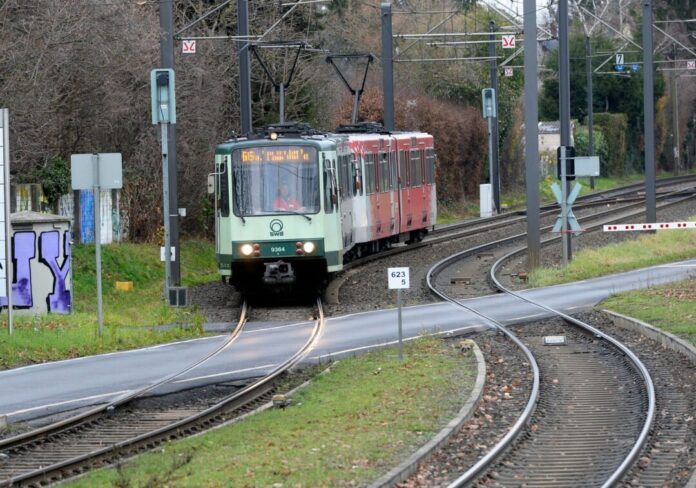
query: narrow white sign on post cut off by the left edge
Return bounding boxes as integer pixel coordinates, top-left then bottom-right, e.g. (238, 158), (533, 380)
(0, 108), (14, 335)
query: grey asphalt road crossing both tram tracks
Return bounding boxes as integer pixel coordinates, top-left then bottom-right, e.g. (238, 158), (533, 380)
(0, 260), (696, 422)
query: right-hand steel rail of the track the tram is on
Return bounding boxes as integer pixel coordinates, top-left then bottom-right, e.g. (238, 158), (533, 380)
(0, 298), (326, 486)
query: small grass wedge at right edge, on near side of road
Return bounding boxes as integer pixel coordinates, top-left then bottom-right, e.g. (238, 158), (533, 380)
(601, 280), (696, 345)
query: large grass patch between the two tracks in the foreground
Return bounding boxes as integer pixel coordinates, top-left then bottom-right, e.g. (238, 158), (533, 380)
(71, 338), (476, 487)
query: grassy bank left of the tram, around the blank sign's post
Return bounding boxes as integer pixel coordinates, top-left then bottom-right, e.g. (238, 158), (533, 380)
(0, 240), (217, 367)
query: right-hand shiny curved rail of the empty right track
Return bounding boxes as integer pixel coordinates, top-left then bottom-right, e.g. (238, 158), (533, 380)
(486, 250), (656, 488)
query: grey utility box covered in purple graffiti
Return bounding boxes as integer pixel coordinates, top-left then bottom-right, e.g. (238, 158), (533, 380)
(0, 212), (72, 313)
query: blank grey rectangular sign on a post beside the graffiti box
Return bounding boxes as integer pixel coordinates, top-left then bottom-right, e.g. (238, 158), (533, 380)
(70, 153), (123, 336)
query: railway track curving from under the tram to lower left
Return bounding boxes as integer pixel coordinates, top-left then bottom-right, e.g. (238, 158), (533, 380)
(0, 299), (325, 487)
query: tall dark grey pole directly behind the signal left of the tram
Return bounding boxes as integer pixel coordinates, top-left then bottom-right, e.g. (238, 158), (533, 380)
(159, 0), (181, 286)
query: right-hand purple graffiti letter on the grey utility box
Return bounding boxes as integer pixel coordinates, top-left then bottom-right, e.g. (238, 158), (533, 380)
(39, 230), (72, 313)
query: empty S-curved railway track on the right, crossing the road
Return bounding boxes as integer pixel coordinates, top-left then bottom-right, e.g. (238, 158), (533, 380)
(427, 235), (655, 487)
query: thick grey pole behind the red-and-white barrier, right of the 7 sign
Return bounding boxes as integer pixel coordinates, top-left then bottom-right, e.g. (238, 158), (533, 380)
(643, 0), (657, 223)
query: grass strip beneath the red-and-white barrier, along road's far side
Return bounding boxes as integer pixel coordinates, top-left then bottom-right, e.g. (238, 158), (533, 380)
(529, 218), (696, 287)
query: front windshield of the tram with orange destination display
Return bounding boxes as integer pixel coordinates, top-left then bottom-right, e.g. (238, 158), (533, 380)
(232, 146), (319, 217)
